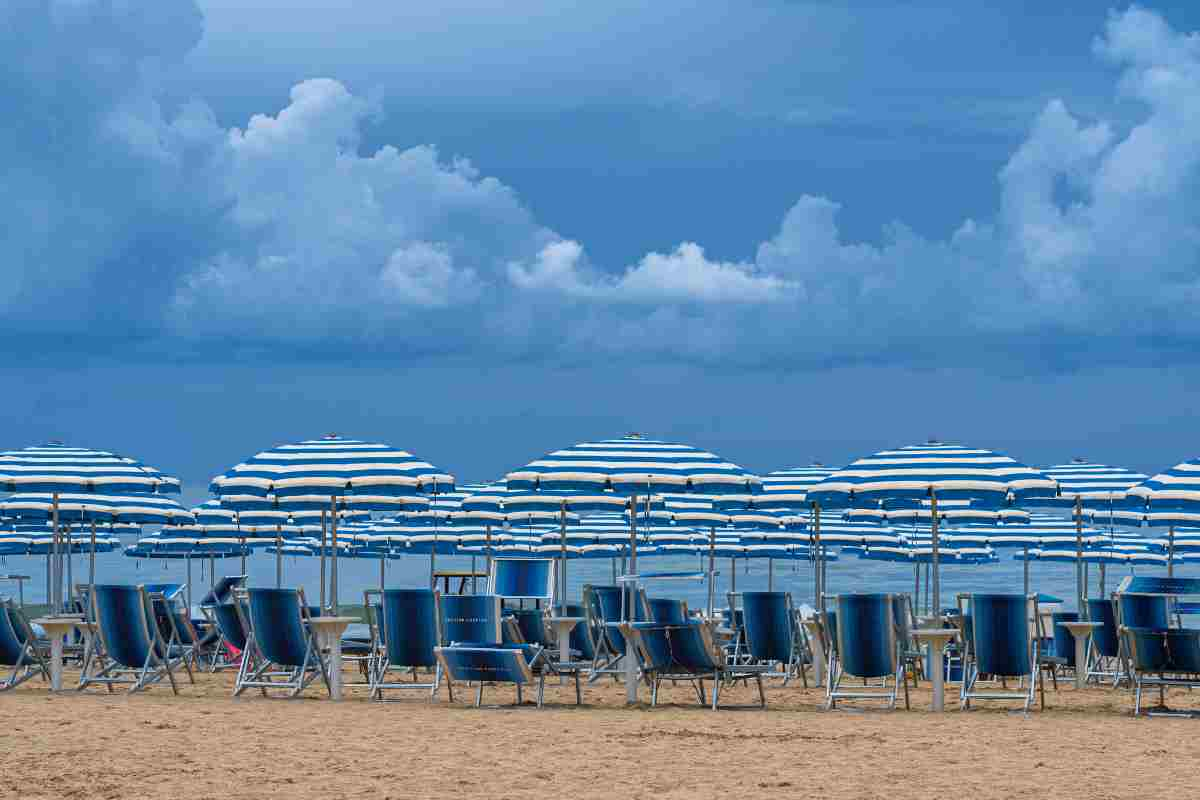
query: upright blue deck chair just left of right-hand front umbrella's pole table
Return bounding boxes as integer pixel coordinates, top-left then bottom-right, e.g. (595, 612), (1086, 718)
(826, 594), (908, 710)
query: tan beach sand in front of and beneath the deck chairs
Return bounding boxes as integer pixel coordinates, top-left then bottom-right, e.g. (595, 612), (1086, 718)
(0, 670), (1200, 800)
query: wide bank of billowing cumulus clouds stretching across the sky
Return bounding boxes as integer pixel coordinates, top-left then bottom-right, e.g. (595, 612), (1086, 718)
(7, 0), (1200, 365)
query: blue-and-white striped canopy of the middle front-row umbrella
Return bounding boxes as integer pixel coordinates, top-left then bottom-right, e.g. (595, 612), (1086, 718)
(505, 435), (762, 497)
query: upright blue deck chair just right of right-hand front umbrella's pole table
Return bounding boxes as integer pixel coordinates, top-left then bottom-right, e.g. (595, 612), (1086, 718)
(961, 594), (1045, 712)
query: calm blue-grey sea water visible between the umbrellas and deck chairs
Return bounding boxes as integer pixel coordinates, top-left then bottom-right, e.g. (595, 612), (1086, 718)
(7, 551), (1200, 608)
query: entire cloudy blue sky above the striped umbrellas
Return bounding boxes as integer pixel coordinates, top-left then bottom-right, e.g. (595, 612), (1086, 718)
(0, 0), (1200, 489)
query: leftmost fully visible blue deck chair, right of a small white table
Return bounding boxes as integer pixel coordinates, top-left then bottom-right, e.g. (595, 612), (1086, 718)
(79, 584), (191, 694)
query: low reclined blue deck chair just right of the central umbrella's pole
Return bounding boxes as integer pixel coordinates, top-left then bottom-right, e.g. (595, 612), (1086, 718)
(622, 621), (769, 711)
